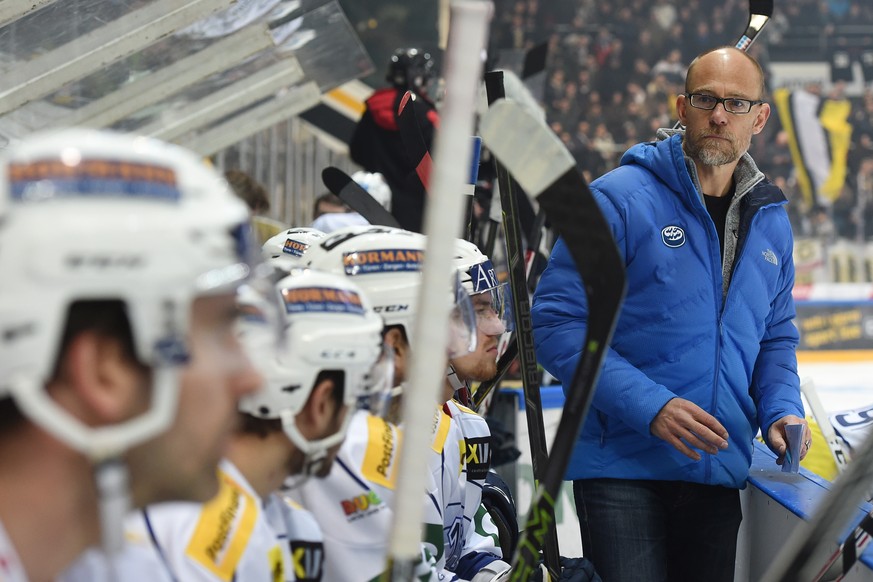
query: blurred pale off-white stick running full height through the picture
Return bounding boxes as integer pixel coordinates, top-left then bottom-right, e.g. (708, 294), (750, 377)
(387, 0), (493, 582)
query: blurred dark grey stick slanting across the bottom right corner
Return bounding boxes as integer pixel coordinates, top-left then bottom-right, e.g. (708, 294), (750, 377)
(763, 434), (873, 582)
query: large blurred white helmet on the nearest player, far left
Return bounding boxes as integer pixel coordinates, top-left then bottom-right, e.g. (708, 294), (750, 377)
(0, 129), (257, 460)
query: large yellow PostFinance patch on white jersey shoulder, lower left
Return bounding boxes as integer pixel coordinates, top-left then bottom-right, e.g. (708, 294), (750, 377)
(185, 471), (259, 582)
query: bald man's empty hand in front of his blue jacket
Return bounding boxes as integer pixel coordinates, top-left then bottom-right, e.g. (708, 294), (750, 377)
(649, 398), (728, 461)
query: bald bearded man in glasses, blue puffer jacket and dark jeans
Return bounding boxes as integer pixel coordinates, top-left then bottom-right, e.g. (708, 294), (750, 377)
(533, 47), (810, 582)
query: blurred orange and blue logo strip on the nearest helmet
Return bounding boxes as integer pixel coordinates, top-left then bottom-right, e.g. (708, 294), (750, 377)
(9, 159), (181, 202)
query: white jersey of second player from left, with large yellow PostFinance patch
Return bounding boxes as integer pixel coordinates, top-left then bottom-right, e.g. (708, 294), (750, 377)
(62, 461), (324, 582)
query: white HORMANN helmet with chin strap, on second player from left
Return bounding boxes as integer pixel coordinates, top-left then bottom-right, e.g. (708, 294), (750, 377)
(240, 269), (394, 473)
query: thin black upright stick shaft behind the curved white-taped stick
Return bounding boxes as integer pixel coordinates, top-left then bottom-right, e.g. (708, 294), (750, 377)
(485, 71), (561, 579)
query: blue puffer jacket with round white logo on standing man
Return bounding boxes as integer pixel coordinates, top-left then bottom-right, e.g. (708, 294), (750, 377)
(532, 135), (803, 488)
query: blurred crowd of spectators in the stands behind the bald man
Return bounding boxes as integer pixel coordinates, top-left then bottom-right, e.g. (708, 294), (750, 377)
(492, 0), (873, 241)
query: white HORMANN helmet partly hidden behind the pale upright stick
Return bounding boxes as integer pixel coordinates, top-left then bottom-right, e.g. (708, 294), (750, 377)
(307, 226), (476, 356)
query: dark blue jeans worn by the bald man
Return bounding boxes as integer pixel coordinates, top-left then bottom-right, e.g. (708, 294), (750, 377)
(573, 479), (743, 582)
